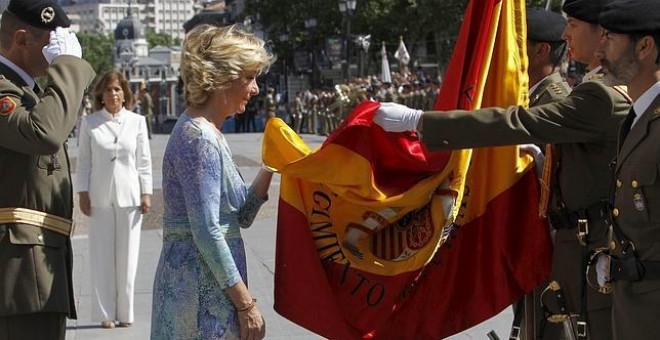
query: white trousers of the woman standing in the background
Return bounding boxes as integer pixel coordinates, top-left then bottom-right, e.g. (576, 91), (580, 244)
(88, 203), (142, 322)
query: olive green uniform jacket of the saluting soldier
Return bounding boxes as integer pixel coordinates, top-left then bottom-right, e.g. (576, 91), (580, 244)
(0, 56), (95, 318)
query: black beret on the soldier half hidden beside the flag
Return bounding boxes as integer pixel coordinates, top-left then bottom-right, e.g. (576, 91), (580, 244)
(527, 8), (566, 42)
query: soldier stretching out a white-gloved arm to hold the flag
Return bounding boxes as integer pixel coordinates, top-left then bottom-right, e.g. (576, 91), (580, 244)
(374, 0), (630, 340)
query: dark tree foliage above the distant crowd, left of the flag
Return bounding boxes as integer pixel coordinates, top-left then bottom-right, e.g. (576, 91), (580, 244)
(245, 0), (467, 75)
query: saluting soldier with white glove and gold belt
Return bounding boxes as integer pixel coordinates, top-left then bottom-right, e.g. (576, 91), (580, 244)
(0, 0), (95, 340)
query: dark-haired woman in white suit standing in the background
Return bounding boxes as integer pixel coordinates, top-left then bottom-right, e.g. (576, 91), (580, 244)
(77, 71), (152, 328)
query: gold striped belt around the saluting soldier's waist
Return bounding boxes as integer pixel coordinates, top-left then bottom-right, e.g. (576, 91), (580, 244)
(0, 208), (73, 237)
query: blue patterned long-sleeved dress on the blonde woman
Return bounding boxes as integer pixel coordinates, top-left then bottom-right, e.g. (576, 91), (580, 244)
(151, 114), (264, 340)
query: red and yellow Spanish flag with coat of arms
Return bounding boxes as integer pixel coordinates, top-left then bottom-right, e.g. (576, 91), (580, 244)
(263, 0), (550, 339)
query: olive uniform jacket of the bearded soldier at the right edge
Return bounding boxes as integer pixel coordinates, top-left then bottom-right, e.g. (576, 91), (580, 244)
(612, 96), (660, 340)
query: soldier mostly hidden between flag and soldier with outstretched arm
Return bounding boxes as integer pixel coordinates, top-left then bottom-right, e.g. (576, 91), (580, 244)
(512, 8), (571, 340)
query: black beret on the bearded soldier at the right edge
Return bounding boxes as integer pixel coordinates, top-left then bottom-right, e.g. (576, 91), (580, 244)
(598, 0), (660, 33)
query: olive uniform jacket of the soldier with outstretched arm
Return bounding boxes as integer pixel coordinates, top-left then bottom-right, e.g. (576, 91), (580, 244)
(422, 77), (630, 340)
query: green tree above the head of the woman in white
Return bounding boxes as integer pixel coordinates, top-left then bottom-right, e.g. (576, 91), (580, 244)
(78, 33), (115, 82)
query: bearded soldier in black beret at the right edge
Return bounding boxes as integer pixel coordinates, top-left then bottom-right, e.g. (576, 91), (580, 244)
(597, 0), (660, 340)
